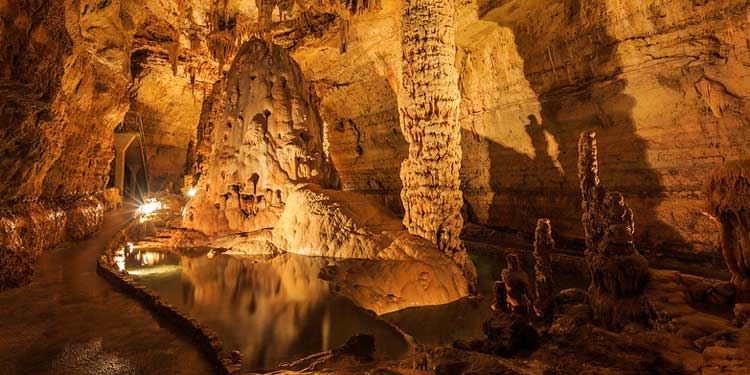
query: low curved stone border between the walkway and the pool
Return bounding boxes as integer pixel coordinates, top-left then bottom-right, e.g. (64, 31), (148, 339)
(96, 220), (241, 374)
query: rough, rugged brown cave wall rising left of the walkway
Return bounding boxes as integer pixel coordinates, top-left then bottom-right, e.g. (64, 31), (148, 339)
(0, 0), (130, 290)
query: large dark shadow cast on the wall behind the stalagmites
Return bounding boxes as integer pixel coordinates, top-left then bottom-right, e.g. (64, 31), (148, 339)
(470, 0), (690, 264)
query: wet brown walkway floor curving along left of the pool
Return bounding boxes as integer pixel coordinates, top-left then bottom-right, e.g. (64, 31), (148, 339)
(0, 210), (212, 375)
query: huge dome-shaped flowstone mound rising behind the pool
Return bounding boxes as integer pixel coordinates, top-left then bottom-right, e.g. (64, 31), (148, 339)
(184, 38), (331, 234)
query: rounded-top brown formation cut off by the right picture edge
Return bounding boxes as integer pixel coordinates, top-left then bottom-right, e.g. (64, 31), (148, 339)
(706, 160), (750, 303)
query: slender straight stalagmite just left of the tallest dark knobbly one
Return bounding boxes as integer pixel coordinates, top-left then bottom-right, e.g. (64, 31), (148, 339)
(534, 219), (555, 318)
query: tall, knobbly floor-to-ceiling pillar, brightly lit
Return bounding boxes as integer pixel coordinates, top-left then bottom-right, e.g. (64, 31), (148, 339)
(398, 0), (476, 280)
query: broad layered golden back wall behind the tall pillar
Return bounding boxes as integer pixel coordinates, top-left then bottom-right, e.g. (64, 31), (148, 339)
(294, 0), (750, 257)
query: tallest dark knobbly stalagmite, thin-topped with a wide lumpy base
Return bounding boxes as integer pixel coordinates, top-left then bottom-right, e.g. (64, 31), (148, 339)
(578, 132), (649, 330)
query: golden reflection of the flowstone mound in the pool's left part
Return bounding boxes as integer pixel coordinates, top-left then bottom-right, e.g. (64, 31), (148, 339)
(125, 249), (408, 371)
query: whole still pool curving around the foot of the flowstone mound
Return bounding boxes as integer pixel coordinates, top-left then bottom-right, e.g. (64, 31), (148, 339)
(125, 245), (584, 371)
